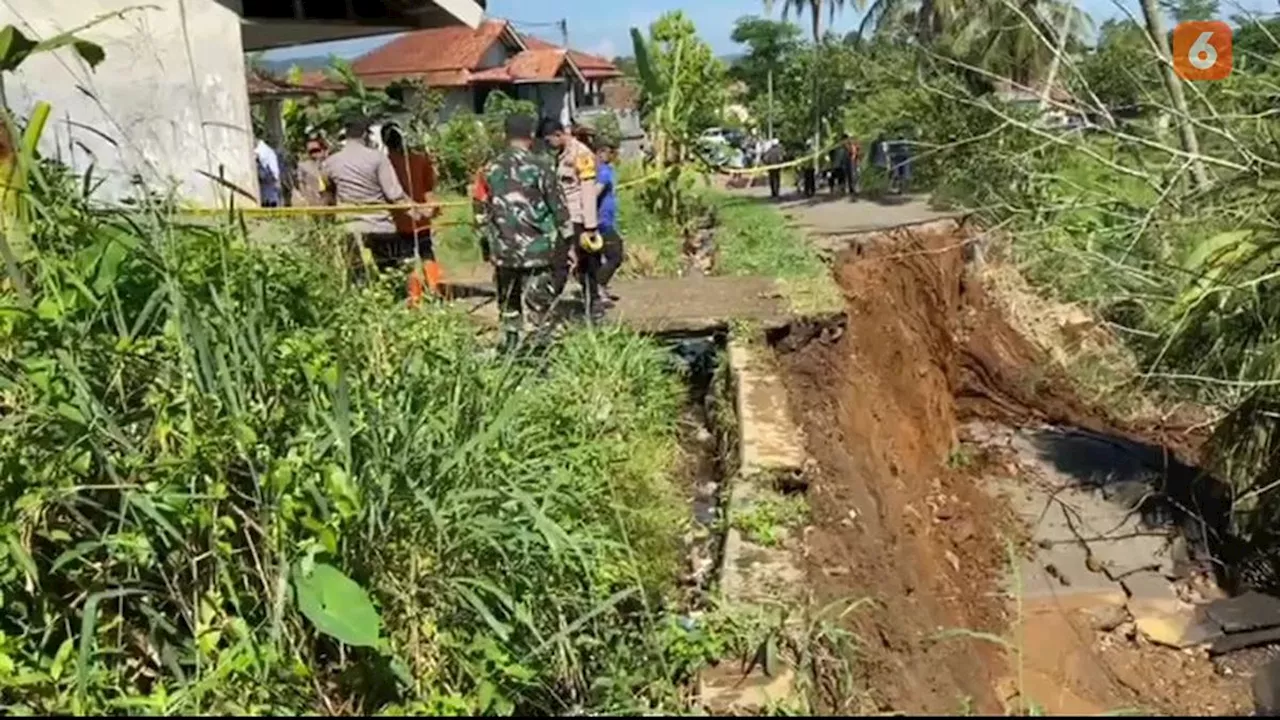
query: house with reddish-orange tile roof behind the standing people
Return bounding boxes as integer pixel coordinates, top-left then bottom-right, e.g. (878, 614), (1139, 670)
(352, 19), (622, 123)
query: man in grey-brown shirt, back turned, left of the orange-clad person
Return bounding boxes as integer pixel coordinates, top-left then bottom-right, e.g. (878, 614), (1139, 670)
(321, 118), (421, 283)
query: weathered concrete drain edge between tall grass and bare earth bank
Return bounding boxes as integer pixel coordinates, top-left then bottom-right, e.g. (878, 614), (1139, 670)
(669, 328), (808, 715)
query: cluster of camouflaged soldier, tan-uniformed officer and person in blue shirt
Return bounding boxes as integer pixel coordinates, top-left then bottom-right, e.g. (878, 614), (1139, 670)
(471, 114), (623, 348)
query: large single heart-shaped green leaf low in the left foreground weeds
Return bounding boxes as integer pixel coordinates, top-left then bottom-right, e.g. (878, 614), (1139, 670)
(293, 562), (381, 647)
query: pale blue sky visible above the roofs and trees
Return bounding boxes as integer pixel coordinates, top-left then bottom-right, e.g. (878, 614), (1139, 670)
(266, 0), (1280, 59)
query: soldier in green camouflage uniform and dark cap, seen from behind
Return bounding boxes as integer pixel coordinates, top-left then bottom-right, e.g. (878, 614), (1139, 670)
(483, 115), (572, 350)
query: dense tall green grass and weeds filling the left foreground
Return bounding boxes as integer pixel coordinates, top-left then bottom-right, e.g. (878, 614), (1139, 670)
(0, 154), (690, 714)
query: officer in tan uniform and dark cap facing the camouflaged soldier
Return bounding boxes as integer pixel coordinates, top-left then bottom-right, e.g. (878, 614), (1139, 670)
(543, 119), (604, 320)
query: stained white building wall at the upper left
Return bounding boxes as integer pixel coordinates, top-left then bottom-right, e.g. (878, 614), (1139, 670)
(0, 0), (257, 204)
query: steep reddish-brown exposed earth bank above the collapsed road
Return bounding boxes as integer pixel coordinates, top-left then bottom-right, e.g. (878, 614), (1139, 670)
(780, 222), (1244, 714)
